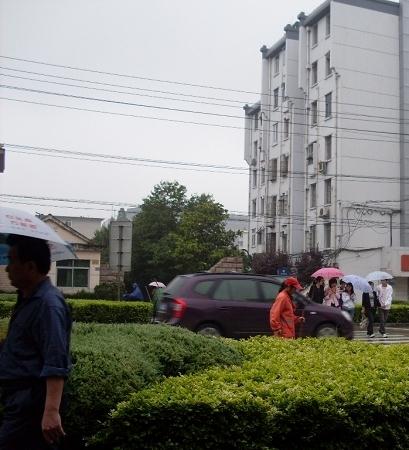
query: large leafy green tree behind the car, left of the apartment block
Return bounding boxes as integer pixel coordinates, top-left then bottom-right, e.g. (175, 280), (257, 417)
(127, 182), (237, 284)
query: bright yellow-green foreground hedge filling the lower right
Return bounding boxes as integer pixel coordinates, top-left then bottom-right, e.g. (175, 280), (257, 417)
(92, 337), (409, 450)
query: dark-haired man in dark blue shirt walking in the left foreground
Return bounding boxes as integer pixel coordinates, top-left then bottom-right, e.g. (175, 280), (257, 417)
(0, 235), (71, 450)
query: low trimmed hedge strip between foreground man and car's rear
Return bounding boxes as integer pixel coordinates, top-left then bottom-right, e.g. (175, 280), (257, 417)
(67, 300), (152, 323)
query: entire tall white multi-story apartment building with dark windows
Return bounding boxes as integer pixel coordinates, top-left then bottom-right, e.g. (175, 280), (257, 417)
(245, 0), (409, 296)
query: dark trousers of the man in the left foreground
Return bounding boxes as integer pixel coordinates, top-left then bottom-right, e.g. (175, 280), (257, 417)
(0, 380), (56, 450)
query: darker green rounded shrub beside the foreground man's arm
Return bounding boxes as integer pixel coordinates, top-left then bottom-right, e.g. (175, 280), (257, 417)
(64, 324), (242, 449)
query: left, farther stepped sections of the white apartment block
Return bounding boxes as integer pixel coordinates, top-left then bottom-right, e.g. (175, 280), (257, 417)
(245, 23), (304, 253)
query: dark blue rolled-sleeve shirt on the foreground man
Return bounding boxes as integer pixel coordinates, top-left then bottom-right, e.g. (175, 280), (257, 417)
(0, 278), (72, 380)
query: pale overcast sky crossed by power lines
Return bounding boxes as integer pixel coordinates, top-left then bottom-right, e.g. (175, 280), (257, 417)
(0, 0), (322, 218)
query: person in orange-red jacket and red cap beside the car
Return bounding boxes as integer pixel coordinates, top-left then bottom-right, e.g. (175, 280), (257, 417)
(270, 277), (305, 339)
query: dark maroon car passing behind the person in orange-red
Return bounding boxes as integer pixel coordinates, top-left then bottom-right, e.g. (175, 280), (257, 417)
(154, 273), (353, 339)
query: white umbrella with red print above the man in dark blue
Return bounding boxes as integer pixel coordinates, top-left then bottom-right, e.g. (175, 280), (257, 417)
(0, 206), (76, 264)
